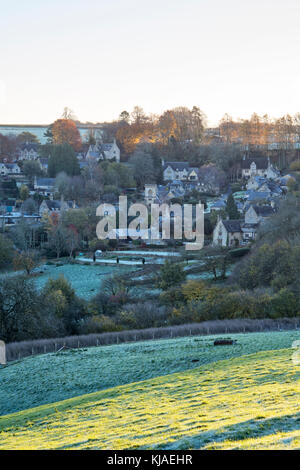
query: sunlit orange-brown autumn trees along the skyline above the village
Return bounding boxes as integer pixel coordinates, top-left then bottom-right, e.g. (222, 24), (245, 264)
(0, 106), (300, 181)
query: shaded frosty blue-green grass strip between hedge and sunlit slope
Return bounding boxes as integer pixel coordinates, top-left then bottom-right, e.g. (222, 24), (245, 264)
(0, 331), (300, 415)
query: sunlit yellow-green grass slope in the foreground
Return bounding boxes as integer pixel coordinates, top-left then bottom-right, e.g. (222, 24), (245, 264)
(0, 348), (300, 449)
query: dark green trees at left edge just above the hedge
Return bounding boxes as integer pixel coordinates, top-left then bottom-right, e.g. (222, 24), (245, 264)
(0, 276), (87, 342)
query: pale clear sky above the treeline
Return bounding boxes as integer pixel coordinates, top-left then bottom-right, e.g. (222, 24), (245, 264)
(0, 0), (300, 125)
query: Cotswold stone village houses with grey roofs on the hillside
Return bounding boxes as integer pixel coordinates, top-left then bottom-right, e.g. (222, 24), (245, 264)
(0, 123), (295, 250)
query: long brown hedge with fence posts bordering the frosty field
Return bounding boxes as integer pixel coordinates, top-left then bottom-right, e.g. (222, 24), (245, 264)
(6, 318), (300, 362)
